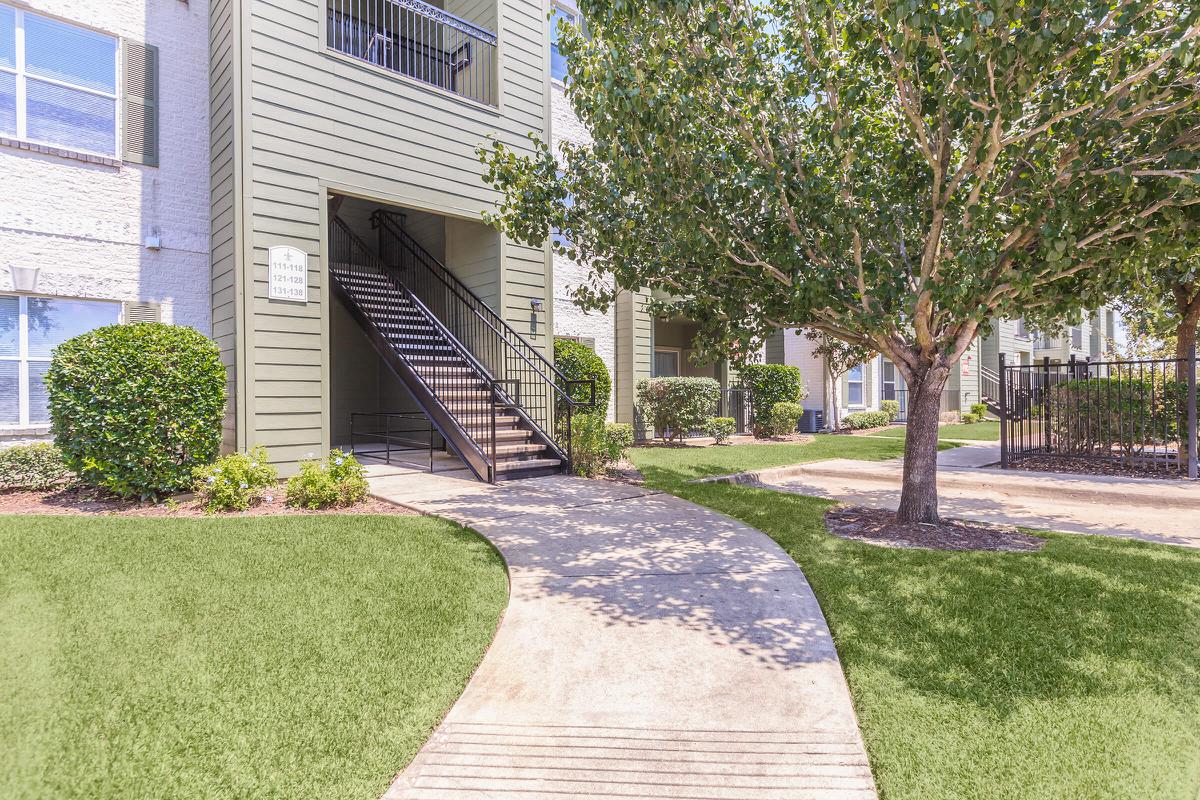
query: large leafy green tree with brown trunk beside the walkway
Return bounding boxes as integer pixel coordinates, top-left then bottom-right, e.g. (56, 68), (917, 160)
(482, 0), (1200, 522)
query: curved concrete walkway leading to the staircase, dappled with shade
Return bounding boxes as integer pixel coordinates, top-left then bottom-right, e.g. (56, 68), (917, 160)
(371, 470), (875, 800)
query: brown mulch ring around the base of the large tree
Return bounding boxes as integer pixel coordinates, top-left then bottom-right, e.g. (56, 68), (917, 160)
(826, 505), (1045, 553)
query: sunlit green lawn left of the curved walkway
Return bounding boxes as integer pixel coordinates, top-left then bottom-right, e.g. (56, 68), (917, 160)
(0, 516), (508, 800)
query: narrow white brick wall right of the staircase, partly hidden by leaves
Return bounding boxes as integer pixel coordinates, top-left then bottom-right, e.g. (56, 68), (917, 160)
(550, 85), (617, 420)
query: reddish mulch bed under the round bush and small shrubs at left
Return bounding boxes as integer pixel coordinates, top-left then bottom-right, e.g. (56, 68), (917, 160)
(0, 487), (415, 517)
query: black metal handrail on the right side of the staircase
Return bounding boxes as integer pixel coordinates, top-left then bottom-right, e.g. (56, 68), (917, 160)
(371, 210), (596, 457)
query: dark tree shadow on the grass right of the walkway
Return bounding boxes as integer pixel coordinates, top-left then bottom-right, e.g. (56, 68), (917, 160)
(672, 479), (1200, 712)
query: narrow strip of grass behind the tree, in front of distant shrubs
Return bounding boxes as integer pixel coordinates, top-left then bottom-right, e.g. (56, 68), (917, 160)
(634, 435), (954, 479)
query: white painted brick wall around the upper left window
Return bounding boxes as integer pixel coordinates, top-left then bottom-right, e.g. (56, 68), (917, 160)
(0, 0), (211, 333)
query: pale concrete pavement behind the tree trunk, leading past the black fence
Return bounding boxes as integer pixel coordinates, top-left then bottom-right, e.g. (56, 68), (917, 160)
(709, 445), (1200, 547)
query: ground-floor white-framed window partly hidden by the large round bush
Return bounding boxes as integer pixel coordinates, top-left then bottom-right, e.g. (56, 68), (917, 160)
(0, 295), (121, 426)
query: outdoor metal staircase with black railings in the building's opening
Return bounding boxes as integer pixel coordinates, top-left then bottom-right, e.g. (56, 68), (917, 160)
(330, 211), (595, 482)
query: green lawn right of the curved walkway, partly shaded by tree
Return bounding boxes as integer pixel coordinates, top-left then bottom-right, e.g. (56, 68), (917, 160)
(632, 448), (1200, 800)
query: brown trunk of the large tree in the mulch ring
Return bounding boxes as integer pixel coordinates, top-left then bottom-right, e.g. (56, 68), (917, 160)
(896, 367), (950, 523)
